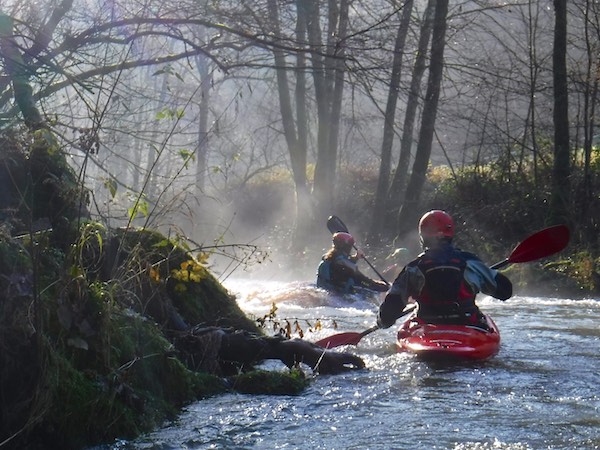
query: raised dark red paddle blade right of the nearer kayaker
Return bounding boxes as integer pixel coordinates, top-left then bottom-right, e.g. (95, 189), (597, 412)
(508, 225), (570, 263)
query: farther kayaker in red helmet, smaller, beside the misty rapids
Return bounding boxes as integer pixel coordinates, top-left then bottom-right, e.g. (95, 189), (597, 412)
(317, 232), (388, 294)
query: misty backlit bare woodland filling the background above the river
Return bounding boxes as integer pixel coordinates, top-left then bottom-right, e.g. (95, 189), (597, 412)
(0, 0), (600, 253)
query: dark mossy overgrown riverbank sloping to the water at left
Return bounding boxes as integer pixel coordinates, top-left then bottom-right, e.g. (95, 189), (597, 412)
(0, 142), (342, 449)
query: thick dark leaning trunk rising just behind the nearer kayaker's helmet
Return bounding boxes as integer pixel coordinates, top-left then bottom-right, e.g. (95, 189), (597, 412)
(398, 0), (448, 234)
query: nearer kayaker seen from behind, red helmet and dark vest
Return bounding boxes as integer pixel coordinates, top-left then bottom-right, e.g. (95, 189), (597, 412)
(377, 210), (512, 328)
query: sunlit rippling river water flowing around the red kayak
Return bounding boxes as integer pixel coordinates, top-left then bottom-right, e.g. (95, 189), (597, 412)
(105, 281), (600, 450)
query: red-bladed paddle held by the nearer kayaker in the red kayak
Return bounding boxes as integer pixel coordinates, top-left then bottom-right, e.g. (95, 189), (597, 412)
(315, 225), (570, 348)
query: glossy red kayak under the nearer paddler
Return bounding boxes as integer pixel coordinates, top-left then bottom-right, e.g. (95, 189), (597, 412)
(396, 315), (500, 361)
